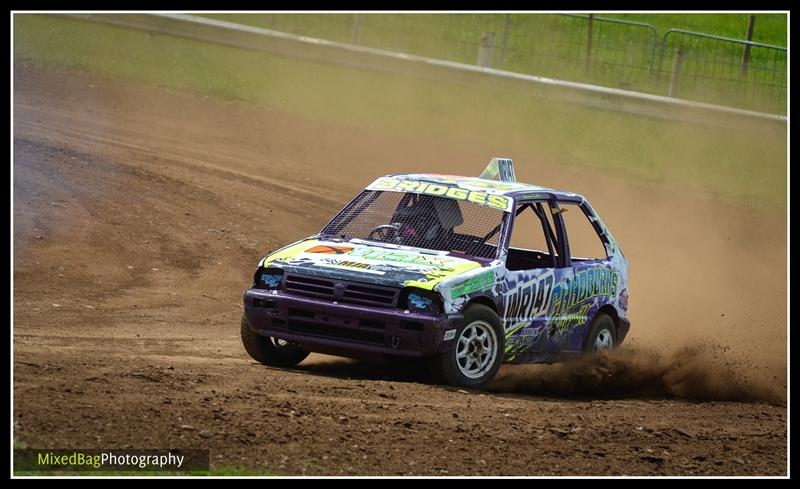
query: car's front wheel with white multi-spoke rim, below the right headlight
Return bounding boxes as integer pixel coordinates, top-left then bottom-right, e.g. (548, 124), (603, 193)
(428, 304), (505, 389)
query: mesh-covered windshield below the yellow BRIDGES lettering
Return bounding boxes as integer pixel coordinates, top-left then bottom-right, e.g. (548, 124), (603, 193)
(322, 190), (506, 258)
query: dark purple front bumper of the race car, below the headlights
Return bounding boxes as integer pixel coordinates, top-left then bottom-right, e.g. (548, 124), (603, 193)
(244, 289), (463, 356)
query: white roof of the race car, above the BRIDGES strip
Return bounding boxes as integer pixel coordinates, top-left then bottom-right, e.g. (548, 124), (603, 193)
(373, 173), (583, 200)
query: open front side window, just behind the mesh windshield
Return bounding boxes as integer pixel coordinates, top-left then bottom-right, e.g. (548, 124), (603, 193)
(506, 203), (556, 270)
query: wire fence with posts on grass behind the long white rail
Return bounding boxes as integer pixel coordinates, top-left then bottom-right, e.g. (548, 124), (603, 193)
(203, 14), (788, 114)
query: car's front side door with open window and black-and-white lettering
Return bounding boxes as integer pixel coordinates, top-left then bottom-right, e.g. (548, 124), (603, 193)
(502, 199), (573, 363)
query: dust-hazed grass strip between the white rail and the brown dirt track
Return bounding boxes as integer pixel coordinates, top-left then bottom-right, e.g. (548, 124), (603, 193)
(14, 15), (787, 208)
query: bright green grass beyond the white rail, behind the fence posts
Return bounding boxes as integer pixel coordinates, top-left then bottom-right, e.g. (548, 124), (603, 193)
(200, 14), (787, 113)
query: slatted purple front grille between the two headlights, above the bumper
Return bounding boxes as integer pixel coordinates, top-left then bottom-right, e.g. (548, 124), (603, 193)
(284, 275), (400, 307)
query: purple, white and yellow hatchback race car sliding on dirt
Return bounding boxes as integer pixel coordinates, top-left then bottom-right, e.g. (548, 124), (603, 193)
(241, 158), (630, 388)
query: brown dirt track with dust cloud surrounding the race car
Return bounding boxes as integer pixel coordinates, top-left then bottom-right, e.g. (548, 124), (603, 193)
(14, 65), (787, 475)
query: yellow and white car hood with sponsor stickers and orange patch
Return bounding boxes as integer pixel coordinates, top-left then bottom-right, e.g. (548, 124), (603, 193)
(263, 238), (482, 290)
